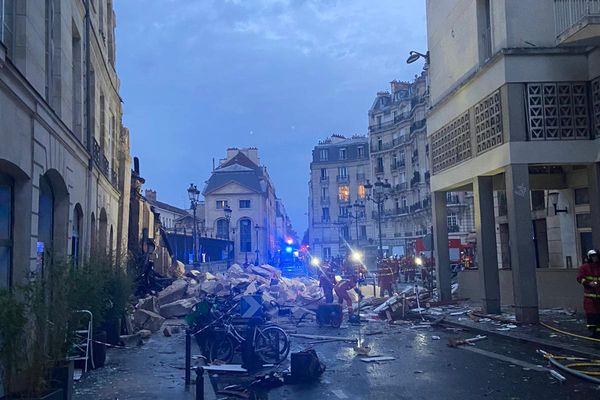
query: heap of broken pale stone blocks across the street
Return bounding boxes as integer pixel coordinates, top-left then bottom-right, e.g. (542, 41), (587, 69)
(132, 264), (322, 332)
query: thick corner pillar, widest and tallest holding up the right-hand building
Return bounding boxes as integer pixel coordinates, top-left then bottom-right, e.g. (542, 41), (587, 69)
(505, 164), (539, 323)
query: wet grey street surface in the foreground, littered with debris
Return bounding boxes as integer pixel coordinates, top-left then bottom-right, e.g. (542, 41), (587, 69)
(74, 316), (600, 400)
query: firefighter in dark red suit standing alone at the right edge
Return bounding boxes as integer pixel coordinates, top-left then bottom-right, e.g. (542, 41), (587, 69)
(577, 250), (600, 337)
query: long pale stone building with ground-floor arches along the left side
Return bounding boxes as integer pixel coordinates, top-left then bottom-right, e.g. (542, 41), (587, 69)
(0, 0), (130, 287)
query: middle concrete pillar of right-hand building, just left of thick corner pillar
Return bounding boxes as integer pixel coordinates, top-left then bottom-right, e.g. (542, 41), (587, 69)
(473, 176), (501, 314)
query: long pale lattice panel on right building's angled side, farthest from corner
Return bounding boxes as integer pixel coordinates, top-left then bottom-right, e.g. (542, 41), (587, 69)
(431, 110), (472, 174)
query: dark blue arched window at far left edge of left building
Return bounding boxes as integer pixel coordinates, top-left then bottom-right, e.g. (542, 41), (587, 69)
(0, 173), (14, 289)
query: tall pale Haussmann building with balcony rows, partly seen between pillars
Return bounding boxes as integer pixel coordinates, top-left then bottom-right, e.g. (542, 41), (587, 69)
(369, 71), (473, 261)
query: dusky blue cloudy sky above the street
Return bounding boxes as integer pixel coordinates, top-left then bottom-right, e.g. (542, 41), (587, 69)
(114, 0), (427, 237)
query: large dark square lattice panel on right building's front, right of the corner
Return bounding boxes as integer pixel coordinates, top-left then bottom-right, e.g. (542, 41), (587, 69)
(527, 82), (590, 140)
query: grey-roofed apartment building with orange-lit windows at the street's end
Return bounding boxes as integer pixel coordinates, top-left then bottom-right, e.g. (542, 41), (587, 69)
(308, 135), (371, 260)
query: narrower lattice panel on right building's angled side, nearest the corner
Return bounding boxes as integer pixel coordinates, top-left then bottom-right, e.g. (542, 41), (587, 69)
(474, 90), (504, 155)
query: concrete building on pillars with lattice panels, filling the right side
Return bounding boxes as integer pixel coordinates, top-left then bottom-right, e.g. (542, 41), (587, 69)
(427, 0), (600, 322)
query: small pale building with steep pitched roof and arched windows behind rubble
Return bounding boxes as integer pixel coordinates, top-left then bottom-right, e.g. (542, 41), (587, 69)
(202, 148), (281, 263)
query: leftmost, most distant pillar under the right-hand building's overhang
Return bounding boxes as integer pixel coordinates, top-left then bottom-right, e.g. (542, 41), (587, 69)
(431, 191), (452, 301)
